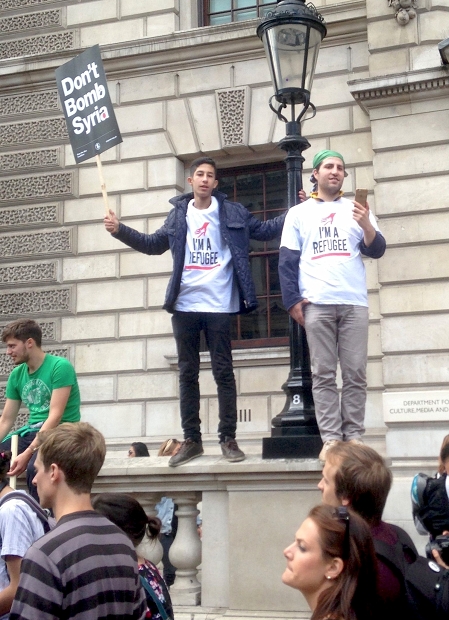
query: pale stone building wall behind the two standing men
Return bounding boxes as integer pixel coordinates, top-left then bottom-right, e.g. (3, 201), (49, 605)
(0, 0), (449, 552)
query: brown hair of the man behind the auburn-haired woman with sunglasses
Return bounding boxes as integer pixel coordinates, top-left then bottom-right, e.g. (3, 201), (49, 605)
(326, 441), (392, 525)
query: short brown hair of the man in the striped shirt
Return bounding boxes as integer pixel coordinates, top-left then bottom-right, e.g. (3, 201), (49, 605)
(37, 422), (106, 494)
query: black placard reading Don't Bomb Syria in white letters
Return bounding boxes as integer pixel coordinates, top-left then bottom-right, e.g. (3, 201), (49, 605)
(56, 45), (123, 164)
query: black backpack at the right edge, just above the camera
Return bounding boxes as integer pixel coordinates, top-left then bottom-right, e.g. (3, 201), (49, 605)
(411, 473), (449, 538)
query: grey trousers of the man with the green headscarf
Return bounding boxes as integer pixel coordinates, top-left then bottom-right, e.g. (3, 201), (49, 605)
(304, 304), (368, 442)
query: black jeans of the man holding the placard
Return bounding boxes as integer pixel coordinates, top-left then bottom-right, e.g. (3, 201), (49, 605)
(172, 312), (237, 441)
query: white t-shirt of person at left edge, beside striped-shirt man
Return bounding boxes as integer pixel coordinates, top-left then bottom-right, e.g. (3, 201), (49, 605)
(0, 491), (44, 620)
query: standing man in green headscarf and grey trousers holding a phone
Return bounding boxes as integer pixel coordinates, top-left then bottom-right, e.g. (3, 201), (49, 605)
(279, 151), (386, 461)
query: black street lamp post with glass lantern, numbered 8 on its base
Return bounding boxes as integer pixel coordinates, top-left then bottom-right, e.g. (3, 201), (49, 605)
(257, 0), (326, 459)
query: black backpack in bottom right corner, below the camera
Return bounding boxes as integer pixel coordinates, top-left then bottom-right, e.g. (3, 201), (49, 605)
(374, 525), (449, 620)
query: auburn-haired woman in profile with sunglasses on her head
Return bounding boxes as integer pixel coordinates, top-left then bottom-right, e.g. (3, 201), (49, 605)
(282, 504), (377, 620)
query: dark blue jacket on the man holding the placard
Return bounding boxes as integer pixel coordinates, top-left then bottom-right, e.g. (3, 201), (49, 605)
(113, 191), (285, 312)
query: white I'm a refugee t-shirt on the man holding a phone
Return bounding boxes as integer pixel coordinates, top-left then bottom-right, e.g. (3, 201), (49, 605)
(281, 198), (379, 306)
